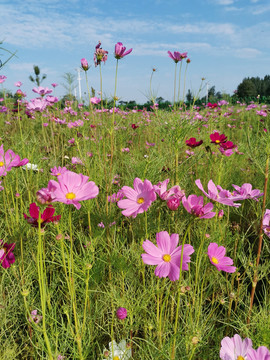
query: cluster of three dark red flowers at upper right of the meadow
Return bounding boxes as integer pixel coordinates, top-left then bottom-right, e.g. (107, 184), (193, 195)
(186, 131), (237, 156)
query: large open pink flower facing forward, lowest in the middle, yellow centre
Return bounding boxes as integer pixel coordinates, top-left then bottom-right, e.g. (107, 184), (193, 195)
(141, 231), (194, 281)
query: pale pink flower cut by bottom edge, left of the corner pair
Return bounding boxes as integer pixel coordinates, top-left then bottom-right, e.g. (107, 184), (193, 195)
(219, 334), (252, 360)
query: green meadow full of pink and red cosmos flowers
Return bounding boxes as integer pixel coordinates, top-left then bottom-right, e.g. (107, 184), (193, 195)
(0, 47), (270, 360)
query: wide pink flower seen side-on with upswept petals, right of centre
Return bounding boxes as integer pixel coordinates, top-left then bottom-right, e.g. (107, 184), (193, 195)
(195, 179), (241, 208)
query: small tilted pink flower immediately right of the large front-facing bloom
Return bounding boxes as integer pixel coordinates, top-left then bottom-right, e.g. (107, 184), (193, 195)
(207, 243), (236, 273)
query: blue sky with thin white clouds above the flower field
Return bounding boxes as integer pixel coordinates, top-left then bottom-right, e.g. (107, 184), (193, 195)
(0, 0), (270, 102)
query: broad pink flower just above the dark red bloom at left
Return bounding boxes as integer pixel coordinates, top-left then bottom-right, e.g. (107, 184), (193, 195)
(48, 171), (99, 210)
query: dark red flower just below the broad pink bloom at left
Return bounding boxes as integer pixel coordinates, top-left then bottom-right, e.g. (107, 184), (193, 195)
(23, 203), (61, 227)
